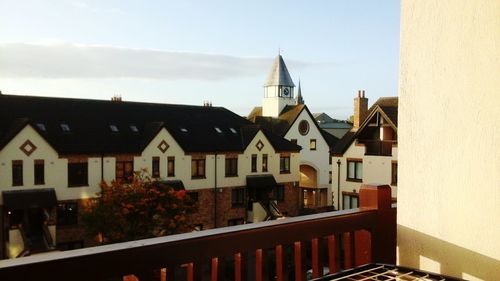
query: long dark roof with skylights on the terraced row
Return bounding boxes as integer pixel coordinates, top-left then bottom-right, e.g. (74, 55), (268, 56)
(0, 95), (300, 154)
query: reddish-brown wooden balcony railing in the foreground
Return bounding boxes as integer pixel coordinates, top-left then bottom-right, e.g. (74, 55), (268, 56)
(0, 185), (396, 281)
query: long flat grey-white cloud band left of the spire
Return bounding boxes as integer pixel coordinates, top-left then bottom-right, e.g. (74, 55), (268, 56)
(0, 43), (310, 80)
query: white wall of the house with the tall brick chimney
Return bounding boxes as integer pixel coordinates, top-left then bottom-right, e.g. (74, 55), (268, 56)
(332, 141), (398, 209)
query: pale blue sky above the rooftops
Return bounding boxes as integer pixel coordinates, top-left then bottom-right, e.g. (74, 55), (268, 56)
(0, 0), (400, 119)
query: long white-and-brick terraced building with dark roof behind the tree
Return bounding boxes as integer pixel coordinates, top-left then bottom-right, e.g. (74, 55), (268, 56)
(0, 94), (300, 258)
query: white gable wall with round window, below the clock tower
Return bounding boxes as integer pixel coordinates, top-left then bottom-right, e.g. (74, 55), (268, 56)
(285, 110), (332, 202)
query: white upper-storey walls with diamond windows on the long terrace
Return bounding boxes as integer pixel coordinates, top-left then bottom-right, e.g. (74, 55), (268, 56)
(0, 125), (300, 201)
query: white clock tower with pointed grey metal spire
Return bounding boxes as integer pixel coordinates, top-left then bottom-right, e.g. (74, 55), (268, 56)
(262, 55), (296, 117)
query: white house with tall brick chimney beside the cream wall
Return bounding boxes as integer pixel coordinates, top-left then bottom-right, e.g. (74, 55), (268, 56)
(332, 91), (398, 209)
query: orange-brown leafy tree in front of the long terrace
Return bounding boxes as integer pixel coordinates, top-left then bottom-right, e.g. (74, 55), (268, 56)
(82, 171), (194, 243)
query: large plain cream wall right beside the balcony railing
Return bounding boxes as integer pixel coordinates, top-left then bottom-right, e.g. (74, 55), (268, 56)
(398, 0), (500, 280)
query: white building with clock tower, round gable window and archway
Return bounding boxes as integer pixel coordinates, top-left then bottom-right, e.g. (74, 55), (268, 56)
(248, 55), (338, 208)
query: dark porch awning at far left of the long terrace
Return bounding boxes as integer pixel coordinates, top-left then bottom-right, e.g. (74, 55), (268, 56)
(2, 188), (57, 210)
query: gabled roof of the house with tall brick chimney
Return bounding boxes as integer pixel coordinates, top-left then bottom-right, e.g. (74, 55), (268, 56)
(331, 97), (398, 155)
